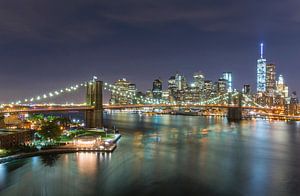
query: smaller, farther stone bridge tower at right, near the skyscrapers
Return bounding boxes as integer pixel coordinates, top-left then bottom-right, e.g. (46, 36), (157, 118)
(227, 92), (242, 121)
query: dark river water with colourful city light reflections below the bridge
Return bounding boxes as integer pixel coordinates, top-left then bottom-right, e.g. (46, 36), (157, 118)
(0, 113), (300, 196)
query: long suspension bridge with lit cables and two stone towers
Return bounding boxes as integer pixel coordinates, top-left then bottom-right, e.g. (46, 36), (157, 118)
(0, 79), (300, 128)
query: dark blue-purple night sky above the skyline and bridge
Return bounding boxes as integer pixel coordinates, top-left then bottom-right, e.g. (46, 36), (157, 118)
(0, 0), (300, 103)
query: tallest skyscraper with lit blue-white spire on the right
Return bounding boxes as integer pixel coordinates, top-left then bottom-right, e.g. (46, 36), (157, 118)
(257, 43), (267, 92)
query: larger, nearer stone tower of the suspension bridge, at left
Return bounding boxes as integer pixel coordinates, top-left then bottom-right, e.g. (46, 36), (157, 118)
(85, 80), (103, 128)
